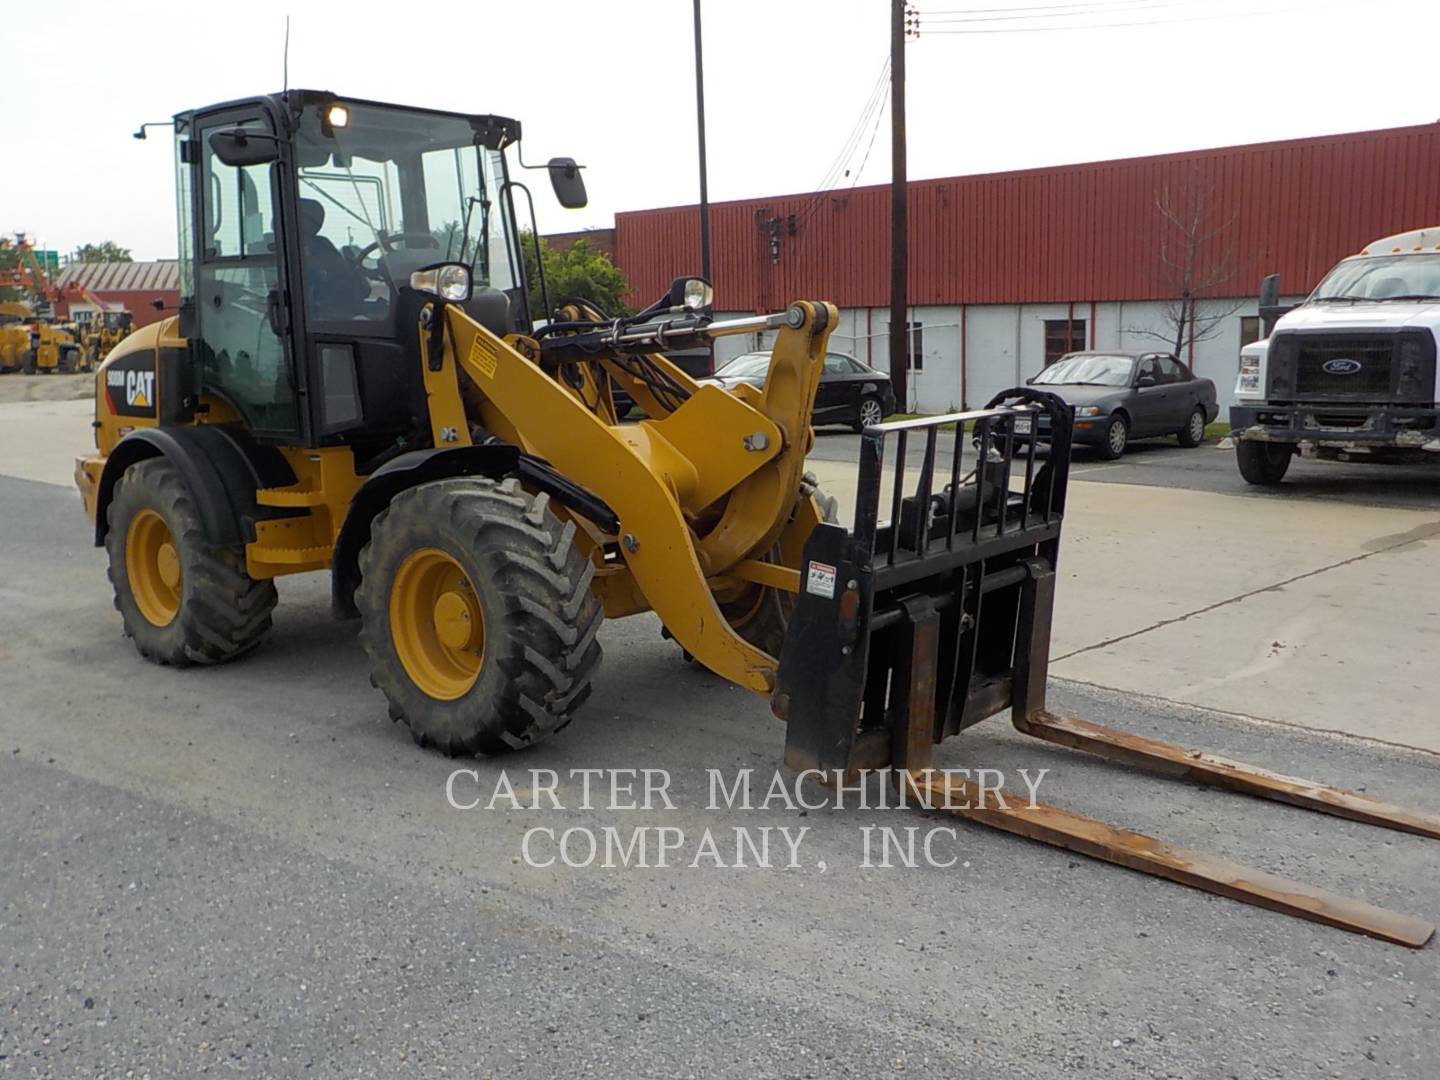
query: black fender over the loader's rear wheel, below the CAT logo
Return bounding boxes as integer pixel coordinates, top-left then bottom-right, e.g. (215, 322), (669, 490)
(95, 423), (295, 547)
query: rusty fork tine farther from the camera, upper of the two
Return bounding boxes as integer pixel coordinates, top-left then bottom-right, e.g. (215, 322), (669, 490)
(1015, 713), (1440, 840)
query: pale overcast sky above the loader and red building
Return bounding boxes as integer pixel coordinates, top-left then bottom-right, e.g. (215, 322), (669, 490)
(0, 0), (1440, 258)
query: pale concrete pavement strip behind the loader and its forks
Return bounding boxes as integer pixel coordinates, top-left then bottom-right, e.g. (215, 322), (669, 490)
(0, 400), (1440, 753)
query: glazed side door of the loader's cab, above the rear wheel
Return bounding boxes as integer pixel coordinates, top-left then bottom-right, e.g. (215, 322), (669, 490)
(194, 107), (302, 442)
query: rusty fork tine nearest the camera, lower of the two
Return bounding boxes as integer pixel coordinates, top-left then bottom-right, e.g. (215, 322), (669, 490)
(907, 772), (1436, 949)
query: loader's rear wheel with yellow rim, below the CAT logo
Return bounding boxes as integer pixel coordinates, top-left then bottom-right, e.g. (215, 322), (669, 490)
(105, 458), (276, 667)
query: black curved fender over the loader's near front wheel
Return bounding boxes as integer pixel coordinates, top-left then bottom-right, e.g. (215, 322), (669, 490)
(330, 441), (619, 619)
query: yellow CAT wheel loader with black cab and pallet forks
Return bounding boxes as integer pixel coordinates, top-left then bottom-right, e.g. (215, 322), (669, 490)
(75, 91), (1440, 948)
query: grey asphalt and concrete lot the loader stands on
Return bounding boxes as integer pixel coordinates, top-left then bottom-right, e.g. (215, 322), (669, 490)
(0, 402), (1440, 1080)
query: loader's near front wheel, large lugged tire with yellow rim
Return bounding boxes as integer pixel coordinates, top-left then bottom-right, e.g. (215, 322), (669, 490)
(365, 478), (603, 756)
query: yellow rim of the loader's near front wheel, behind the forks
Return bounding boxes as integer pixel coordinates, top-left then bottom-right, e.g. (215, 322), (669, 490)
(390, 547), (485, 701)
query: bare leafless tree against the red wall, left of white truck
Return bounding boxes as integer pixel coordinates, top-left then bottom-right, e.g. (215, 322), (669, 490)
(1126, 166), (1246, 357)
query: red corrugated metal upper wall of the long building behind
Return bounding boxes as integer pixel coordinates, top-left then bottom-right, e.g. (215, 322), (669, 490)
(615, 124), (1440, 311)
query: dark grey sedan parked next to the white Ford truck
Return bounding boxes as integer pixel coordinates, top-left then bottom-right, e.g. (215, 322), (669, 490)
(1030, 350), (1220, 458)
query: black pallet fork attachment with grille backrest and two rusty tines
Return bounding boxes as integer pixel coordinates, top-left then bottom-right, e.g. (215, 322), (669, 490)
(772, 389), (1440, 949)
